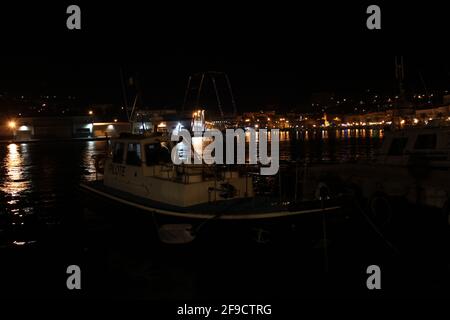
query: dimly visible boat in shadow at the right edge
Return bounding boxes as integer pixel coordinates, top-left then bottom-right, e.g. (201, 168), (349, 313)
(309, 124), (450, 224)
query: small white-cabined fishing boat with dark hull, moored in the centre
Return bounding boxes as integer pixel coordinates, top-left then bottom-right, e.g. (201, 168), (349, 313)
(81, 134), (340, 243)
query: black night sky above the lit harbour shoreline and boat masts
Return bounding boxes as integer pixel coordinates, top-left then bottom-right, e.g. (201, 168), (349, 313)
(0, 1), (450, 110)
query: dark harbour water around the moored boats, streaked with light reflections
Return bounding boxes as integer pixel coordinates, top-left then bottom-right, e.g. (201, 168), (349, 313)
(0, 130), (449, 299)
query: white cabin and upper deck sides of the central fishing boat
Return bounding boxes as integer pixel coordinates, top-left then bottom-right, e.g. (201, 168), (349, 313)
(103, 135), (253, 207)
